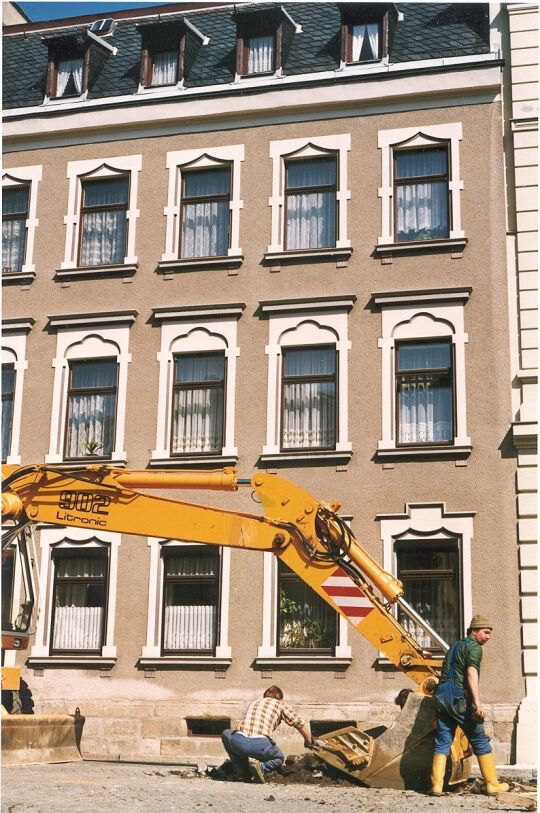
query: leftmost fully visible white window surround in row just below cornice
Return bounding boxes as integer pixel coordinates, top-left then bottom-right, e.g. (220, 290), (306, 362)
(60, 155), (142, 272)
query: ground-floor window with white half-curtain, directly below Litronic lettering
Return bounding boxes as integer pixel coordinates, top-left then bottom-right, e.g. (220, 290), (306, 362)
(51, 549), (108, 654)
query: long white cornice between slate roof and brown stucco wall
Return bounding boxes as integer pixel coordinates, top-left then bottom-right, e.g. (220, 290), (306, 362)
(4, 59), (501, 151)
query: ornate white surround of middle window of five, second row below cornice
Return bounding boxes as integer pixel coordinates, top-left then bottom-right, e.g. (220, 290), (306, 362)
(150, 303), (240, 466)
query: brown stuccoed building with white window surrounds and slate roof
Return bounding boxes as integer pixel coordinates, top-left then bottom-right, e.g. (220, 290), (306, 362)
(2, 3), (528, 762)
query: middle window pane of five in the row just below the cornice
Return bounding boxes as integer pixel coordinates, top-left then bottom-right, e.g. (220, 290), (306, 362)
(181, 166), (231, 257)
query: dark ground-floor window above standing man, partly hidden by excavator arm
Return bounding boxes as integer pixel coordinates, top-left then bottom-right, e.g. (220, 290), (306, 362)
(395, 540), (463, 649)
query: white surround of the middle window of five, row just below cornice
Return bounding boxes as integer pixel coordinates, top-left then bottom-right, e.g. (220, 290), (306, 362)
(161, 144), (244, 265)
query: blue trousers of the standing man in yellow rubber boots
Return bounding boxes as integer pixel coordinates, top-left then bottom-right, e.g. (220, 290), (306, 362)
(435, 681), (491, 757)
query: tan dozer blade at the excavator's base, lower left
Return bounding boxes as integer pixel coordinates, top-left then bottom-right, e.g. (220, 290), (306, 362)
(2, 708), (84, 765)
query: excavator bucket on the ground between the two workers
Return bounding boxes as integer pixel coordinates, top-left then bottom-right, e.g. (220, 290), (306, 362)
(313, 692), (470, 791)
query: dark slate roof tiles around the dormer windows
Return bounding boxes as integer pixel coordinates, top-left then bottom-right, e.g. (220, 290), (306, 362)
(3, 3), (489, 109)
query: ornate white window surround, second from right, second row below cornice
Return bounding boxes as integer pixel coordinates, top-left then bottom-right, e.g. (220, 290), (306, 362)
(260, 296), (356, 461)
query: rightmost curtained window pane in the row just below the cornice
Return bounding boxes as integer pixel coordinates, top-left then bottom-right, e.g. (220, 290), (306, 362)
(394, 147), (449, 242)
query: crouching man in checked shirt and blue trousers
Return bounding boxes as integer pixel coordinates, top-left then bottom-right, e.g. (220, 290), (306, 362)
(221, 686), (313, 783)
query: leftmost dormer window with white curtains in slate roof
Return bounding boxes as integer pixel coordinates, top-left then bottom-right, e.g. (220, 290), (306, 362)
(47, 37), (90, 99)
